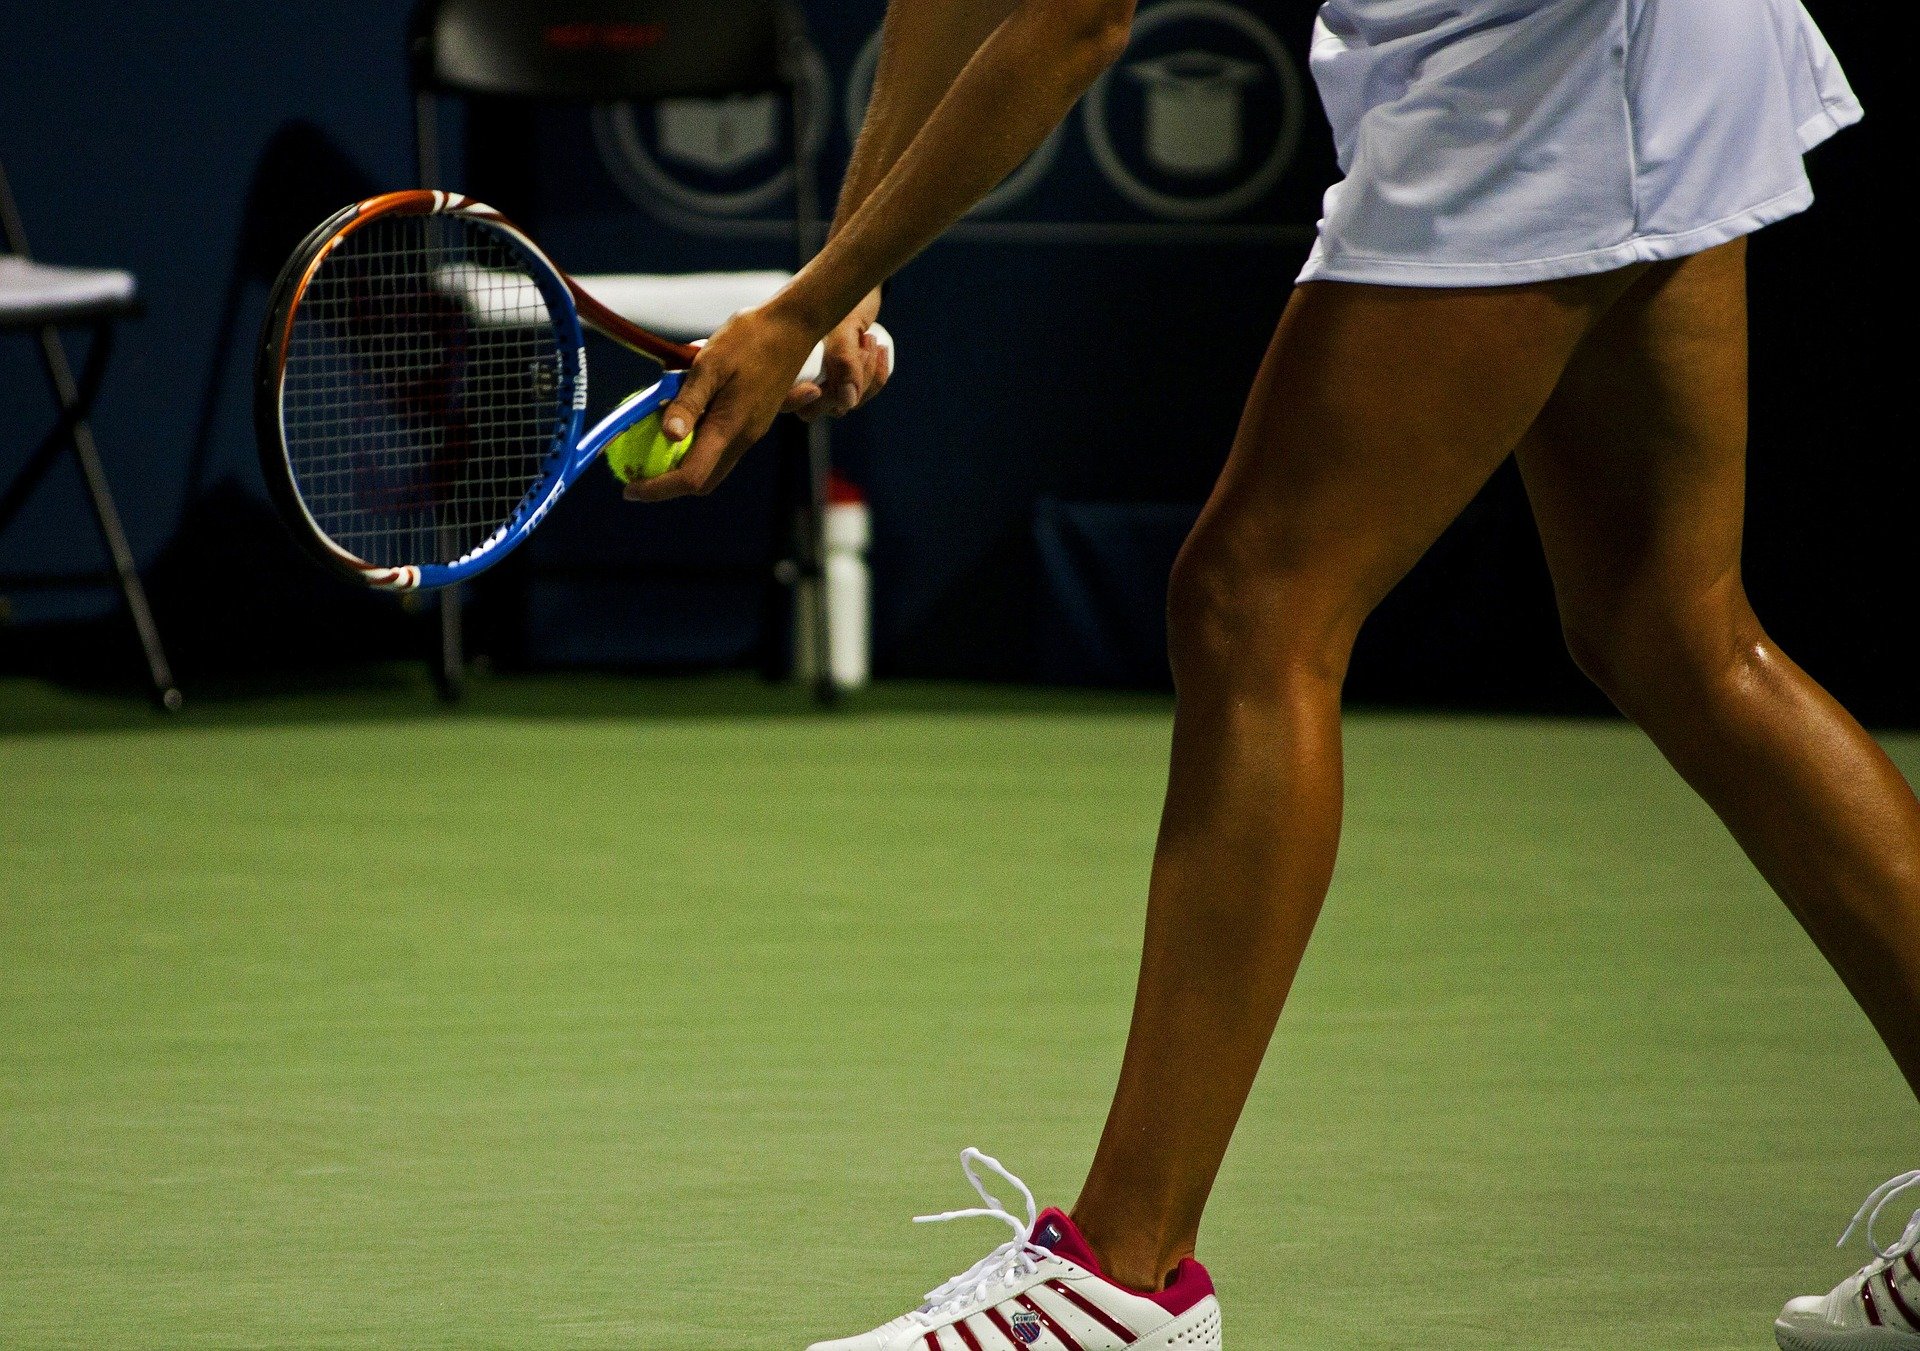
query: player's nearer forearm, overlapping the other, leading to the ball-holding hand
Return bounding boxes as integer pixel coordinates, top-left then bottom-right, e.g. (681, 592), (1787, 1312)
(774, 0), (1133, 334)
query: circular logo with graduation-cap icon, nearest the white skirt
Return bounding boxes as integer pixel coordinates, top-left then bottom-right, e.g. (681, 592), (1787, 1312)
(1081, 0), (1306, 221)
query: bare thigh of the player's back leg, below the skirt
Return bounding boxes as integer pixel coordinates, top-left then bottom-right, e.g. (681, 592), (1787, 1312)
(1519, 240), (1747, 656)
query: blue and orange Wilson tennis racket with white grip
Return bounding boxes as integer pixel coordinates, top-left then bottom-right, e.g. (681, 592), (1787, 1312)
(253, 190), (893, 591)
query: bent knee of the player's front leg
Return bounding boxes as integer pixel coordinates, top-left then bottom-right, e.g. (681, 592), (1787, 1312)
(1167, 526), (1352, 693)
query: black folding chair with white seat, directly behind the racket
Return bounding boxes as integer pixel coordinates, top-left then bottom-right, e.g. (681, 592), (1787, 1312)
(413, 0), (835, 700)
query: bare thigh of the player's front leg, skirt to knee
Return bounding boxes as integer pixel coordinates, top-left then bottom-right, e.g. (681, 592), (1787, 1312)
(1175, 273), (1634, 641)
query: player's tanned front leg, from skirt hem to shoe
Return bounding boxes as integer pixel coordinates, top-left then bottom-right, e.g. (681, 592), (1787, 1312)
(1075, 273), (1634, 1288)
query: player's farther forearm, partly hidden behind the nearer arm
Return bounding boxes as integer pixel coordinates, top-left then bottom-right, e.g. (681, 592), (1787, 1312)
(833, 0), (1020, 232)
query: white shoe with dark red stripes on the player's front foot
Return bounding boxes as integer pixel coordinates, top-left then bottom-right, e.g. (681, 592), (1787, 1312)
(808, 1150), (1219, 1351)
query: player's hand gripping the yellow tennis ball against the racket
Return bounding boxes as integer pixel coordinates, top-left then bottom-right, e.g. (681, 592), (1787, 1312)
(626, 305), (824, 503)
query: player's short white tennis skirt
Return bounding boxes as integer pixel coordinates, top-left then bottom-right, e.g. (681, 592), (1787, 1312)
(1300, 0), (1860, 286)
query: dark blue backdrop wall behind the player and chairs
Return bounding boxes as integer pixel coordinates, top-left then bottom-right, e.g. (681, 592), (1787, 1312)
(0, 0), (1912, 718)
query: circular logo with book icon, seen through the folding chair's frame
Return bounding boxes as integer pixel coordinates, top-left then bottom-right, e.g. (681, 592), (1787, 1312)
(593, 46), (833, 219)
